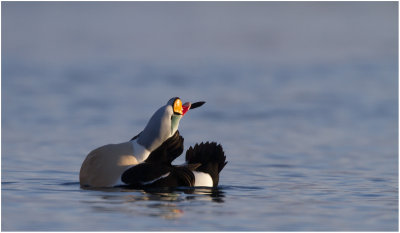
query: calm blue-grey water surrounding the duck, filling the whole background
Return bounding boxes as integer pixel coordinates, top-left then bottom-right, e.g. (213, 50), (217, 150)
(1, 2), (398, 231)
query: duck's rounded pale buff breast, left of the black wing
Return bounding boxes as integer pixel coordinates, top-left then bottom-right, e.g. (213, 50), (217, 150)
(79, 142), (138, 187)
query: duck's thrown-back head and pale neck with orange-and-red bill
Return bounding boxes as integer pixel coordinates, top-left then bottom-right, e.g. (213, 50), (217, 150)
(137, 97), (205, 151)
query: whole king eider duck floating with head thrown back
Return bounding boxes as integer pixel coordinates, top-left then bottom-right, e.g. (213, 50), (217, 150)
(79, 97), (226, 187)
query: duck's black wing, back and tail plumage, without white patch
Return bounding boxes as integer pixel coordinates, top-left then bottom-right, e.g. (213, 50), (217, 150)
(121, 131), (227, 188)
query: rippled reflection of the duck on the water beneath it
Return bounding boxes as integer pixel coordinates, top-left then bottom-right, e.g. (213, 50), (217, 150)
(84, 187), (225, 219)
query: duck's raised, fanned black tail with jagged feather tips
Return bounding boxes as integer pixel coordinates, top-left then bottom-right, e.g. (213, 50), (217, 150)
(186, 142), (228, 187)
